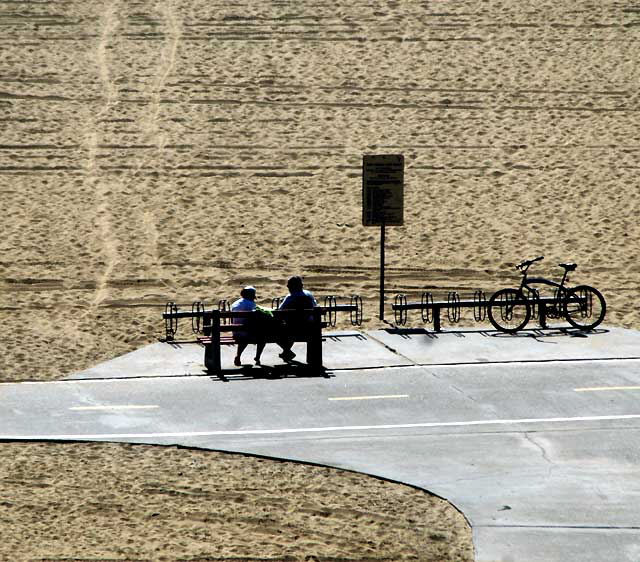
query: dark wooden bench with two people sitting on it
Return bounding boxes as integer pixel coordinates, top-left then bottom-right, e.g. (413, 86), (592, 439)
(204, 307), (327, 373)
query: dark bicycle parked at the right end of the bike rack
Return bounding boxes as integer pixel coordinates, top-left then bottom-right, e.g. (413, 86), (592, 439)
(487, 256), (607, 334)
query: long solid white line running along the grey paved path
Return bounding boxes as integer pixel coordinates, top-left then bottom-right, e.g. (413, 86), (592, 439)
(5, 414), (640, 440)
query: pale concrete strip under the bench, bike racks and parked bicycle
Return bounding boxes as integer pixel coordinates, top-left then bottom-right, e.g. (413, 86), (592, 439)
(69, 327), (640, 379)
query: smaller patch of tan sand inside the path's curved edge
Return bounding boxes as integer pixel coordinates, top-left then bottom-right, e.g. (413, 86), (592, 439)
(0, 443), (472, 560)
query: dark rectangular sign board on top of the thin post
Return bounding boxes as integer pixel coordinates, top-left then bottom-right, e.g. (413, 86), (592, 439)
(362, 154), (404, 226)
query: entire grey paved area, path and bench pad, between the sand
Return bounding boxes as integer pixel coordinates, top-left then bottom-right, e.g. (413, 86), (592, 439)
(0, 328), (640, 562)
